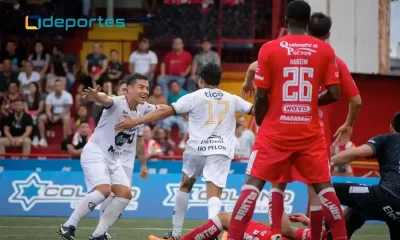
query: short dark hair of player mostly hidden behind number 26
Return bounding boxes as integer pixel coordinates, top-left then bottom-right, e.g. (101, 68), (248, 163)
(308, 12), (332, 37)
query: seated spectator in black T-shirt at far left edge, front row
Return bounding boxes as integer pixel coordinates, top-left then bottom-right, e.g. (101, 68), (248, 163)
(0, 100), (33, 154)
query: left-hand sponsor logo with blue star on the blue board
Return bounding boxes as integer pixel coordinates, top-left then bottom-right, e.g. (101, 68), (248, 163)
(8, 173), (140, 211)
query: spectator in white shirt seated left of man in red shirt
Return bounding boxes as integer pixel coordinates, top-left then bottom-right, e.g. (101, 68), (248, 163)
(129, 38), (158, 90)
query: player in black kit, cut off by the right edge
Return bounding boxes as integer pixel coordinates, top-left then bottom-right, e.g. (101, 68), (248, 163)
(331, 112), (400, 240)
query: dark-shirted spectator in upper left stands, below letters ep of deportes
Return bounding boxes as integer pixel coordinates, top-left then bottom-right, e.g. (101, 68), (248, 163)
(51, 45), (78, 90)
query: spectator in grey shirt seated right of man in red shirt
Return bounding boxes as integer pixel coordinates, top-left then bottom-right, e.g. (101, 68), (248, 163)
(188, 39), (221, 92)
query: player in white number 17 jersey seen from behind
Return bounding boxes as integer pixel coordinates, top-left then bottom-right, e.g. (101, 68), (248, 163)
(116, 63), (253, 239)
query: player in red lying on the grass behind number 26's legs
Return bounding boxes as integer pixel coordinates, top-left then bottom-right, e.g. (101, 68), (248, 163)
(149, 212), (326, 240)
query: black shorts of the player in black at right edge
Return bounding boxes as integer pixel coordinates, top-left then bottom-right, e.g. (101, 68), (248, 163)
(333, 183), (400, 224)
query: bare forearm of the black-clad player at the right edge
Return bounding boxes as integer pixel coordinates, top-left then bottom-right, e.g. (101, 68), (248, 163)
(331, 144), (374, 165)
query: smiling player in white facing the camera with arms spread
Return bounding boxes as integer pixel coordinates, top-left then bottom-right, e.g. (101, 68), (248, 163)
(59, 74), (156, 240)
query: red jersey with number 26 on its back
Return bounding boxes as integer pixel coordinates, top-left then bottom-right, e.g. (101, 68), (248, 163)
(254, 35), (339, 151)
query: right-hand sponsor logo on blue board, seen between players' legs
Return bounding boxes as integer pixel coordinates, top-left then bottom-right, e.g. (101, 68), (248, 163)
(163, 183), (295, 214)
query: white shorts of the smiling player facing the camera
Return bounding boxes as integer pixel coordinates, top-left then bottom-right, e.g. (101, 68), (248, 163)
(81, 149), (132, 192)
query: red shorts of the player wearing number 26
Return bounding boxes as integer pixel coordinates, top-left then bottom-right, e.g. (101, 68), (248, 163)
(246, 137), (331, 184)
